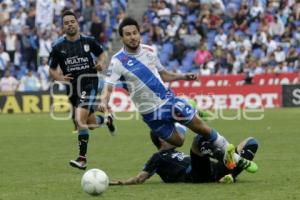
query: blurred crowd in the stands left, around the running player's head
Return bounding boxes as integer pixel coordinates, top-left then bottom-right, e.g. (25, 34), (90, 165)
(0, 0), (127, 92)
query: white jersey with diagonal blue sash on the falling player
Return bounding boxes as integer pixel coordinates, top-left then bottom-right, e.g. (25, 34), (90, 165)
(106, 44), (173, 114)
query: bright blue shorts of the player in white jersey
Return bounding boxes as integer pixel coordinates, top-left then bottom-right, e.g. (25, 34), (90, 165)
(143, 97), (197, 139)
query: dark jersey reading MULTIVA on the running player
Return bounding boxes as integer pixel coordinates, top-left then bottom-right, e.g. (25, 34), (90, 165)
(49, 35), (103, 84)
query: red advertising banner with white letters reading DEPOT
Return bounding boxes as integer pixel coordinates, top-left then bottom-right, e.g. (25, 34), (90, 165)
(111, 85), (282, 112)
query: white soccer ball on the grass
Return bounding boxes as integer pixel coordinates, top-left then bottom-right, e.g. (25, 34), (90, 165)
(81, 169), (109, 195)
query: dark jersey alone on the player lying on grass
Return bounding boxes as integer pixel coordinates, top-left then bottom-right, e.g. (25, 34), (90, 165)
(143, 149), (191, 183)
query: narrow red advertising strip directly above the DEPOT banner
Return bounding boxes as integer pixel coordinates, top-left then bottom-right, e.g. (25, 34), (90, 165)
(170, 73), (298, 88)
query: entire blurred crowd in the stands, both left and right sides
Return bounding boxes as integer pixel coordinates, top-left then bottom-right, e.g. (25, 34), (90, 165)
(0, 0), (300, 92)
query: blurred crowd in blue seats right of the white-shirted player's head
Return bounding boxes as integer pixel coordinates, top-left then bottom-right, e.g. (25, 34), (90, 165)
(141, 0), (300, 76)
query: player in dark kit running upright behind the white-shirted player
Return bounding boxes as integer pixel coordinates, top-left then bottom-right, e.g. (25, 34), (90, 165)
(49, 10), (115, 169)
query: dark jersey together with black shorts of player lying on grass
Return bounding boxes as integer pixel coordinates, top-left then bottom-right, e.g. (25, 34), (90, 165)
(143, 149), (230, 183)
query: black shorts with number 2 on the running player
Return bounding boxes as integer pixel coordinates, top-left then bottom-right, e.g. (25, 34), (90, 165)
(67, 83), (98, 113)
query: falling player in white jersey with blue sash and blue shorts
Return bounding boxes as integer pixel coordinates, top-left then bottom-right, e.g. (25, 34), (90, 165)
(98, 17), (255, 169)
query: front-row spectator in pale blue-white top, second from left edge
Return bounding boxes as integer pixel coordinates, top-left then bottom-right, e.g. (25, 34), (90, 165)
(18, 69), (41, 92)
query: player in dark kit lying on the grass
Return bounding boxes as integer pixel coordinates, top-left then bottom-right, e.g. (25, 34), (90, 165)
(110, 123), (258, 185)
